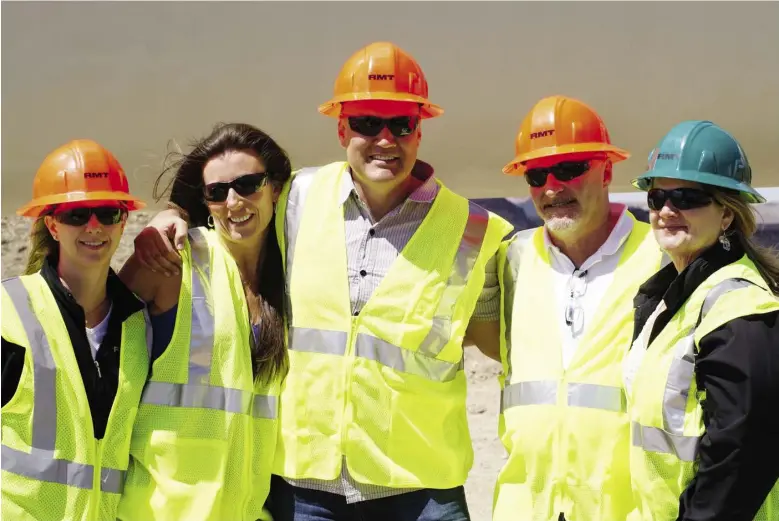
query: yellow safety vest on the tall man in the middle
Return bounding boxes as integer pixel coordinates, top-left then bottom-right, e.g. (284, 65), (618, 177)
(274, 162), (511, 488)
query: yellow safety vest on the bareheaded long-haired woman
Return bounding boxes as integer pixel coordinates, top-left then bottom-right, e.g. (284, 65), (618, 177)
(118, 228), (278, 521)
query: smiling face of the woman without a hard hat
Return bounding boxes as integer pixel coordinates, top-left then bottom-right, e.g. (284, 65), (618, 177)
(203, 150), (278, 246)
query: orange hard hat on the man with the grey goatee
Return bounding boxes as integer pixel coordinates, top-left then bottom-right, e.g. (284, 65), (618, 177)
(503, 96), (630, 175)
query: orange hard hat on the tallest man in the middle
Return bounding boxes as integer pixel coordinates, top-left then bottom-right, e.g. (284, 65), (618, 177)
(319, 42), (444, 118)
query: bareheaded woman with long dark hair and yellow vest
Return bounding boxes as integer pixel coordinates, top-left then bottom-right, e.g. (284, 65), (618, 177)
(118, 123), (291, 521)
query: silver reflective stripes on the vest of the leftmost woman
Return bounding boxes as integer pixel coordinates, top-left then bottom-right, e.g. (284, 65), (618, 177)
(2, 277), (124, 493)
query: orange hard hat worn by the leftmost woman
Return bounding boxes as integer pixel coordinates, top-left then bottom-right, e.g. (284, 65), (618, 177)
(16, 139), (146, 217)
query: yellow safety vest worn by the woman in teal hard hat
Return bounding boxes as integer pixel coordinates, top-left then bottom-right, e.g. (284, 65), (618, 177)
(628, 256), (779, 521)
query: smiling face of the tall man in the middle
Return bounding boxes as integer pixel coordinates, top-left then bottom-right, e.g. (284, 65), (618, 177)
(338, 101), (422, 186)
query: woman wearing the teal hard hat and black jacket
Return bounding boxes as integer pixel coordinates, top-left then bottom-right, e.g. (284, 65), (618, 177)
(624, 121), (779, 521)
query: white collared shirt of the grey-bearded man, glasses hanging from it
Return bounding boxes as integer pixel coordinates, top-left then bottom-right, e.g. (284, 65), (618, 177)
(544, 205), (633, 369)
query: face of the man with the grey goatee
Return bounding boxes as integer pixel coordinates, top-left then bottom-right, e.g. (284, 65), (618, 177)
(526, 150), (611, 235)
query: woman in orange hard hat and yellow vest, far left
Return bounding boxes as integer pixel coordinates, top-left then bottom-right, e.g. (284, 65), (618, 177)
(2, 139), (149, 521)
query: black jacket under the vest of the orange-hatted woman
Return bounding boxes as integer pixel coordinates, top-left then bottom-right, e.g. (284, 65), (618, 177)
(2, 256), (144, 439)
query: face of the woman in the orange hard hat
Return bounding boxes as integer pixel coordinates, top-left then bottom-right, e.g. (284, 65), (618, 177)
(44, 201), (127, 270)
